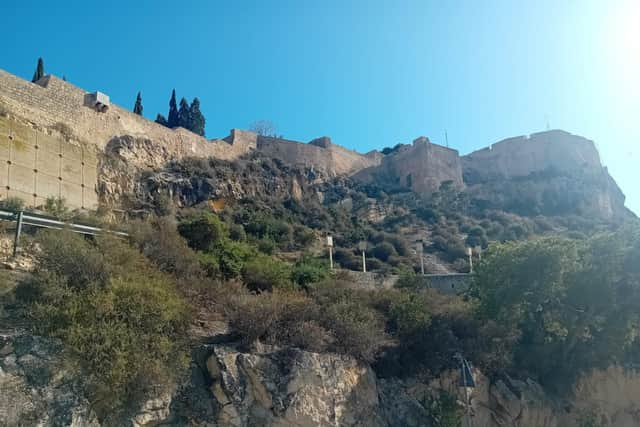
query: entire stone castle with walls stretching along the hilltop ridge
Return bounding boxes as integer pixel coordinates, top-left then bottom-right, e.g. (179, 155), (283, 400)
(0, 70), (624, 217)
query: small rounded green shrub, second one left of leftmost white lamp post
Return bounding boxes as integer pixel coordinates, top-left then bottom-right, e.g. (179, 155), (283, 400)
(242, 255), (292, 291)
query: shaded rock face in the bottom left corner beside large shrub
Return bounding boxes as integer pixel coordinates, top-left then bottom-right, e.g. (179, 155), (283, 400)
(0, 335), (100, 427)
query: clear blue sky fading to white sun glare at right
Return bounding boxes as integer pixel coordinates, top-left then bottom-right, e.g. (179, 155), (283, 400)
(0, 0), (640, 213)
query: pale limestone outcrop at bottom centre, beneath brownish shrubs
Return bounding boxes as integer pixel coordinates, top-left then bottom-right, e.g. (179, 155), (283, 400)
(200, 346), (386, 427)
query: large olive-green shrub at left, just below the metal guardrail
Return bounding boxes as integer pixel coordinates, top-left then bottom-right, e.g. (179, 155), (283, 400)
(17, 232), (189, 416)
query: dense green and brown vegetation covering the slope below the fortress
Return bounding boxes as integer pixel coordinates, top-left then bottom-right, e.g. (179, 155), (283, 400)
(6, 150), (640, 423)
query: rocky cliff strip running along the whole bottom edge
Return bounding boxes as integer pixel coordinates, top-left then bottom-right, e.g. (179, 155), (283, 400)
(5, 334), (640, 427)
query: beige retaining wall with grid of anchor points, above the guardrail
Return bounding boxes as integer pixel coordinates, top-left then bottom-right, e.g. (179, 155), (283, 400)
(0, 116), (98, 209)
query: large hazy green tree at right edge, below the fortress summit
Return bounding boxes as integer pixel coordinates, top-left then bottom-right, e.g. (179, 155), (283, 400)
(470, 229), (640, 390)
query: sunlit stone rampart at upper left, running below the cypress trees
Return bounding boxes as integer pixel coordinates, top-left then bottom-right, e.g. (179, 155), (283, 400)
(0, 70), (249, 167)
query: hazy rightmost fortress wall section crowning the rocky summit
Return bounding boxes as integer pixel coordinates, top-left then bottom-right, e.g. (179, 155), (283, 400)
(462, 130), (601, 179)
